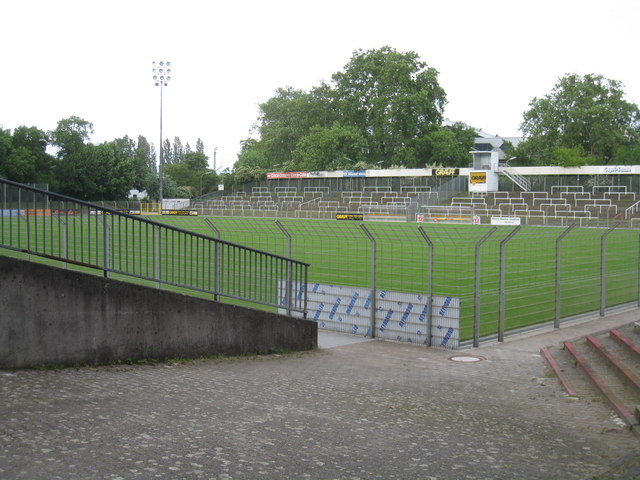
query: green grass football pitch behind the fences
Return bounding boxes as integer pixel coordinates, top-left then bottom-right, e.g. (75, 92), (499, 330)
(0, 216), (639, 340)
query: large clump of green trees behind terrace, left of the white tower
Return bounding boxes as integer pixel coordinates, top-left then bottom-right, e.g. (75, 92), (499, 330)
(234, 47), (446, 179)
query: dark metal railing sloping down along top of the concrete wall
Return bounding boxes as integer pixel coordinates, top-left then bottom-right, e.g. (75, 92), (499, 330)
(0, 179), (309, 316)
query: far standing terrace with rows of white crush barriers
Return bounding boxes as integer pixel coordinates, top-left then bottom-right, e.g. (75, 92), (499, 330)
(193, 186), (637, 225)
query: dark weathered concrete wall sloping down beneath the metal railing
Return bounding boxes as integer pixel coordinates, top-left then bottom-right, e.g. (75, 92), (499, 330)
(0, 255), (318, 368)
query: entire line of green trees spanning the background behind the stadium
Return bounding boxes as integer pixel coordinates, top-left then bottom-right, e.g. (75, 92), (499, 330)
(0, 46), (640, 200)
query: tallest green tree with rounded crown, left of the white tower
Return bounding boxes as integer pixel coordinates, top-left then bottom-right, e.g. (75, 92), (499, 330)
(332, 46), (446, 166)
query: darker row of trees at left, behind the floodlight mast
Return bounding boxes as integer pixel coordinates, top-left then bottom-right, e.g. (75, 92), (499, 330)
(0, 116), (220, 200)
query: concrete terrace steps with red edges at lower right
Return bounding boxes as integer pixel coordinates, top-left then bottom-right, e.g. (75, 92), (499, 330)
(541, 324), (640, 435)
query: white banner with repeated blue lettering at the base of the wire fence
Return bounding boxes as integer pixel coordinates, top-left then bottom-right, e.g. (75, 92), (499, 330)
(279, 282), (460, 349)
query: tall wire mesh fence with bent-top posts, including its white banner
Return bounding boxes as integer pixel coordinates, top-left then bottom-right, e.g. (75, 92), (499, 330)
(156, 217), (640, 348)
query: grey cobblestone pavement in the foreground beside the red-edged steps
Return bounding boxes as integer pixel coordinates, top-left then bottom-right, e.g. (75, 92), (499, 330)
(0, 310), (640, 480)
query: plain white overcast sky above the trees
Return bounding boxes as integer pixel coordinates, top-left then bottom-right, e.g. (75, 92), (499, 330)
(0, 0), (640, 168)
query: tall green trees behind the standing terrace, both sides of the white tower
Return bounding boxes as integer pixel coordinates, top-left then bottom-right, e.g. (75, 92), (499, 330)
(234, 47), (640, 180)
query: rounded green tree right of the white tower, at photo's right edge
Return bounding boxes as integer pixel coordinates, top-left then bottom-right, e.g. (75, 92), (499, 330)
(518, 74), (640, 165)
